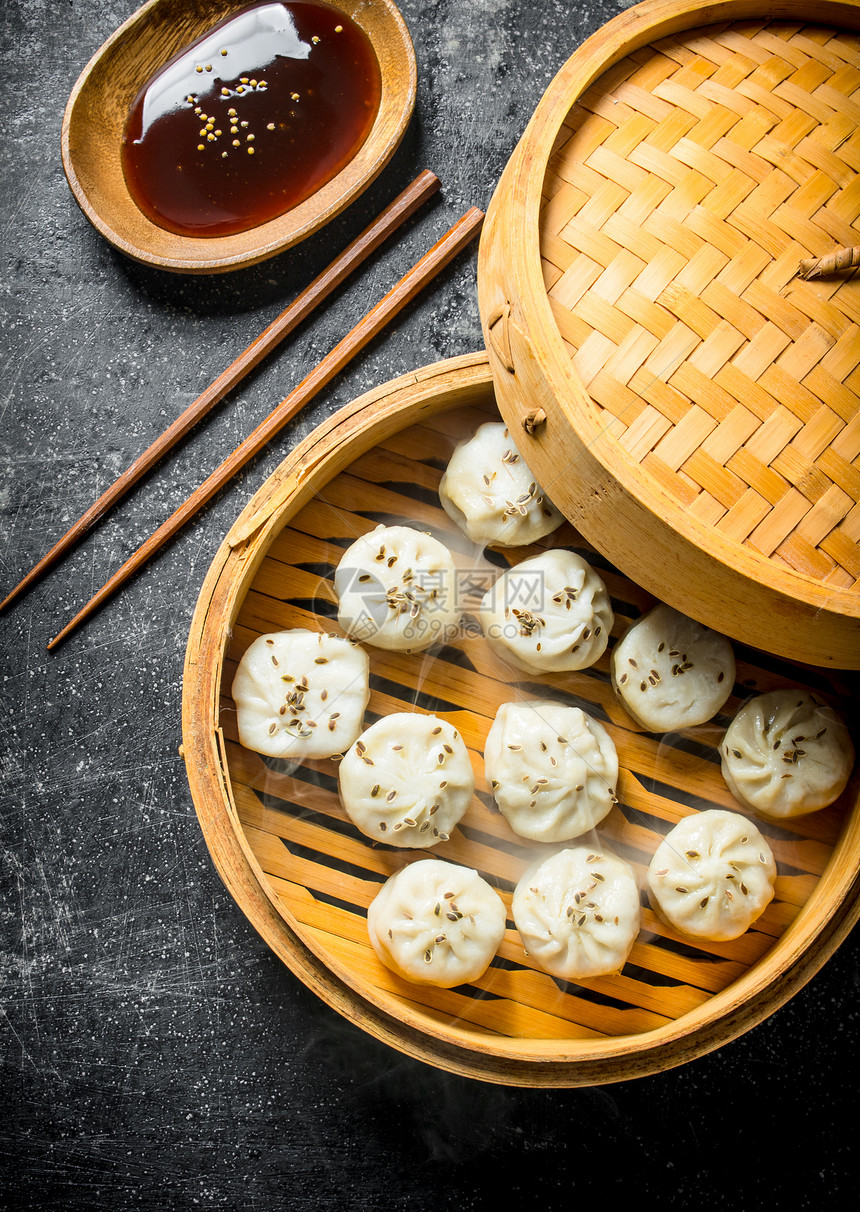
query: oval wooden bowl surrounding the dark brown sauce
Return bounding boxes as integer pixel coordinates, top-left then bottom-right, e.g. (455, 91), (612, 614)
(62, 0), (415, 274)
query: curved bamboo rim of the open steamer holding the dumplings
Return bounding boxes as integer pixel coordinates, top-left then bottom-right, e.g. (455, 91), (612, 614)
(182, 353), (860, 1086)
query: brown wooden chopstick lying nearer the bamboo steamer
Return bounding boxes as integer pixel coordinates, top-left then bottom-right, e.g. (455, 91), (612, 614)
(47, 206), (483, 648)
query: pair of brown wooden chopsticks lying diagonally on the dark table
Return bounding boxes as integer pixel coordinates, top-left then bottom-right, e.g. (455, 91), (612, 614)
(0, 172), (483, 648)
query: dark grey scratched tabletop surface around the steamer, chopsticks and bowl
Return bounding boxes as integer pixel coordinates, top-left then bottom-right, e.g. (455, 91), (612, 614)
(0, 0), (859, 1210)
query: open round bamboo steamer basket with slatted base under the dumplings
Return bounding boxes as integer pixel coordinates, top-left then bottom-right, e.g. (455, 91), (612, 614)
(183, 353), (860, 1087)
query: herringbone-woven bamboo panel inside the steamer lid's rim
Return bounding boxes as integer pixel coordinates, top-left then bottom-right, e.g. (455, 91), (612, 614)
(540, 22), (860, 589)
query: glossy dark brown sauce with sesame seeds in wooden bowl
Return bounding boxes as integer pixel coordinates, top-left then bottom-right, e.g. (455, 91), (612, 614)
(122, 2), (382, 236)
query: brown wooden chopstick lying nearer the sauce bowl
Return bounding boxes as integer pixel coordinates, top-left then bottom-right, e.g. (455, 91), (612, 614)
(0, 171), (440, 611)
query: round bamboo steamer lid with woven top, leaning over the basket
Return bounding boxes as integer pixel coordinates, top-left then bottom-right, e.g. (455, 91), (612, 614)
(478, 0), (860, 669)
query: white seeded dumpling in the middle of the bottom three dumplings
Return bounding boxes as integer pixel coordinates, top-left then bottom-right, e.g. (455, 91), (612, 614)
(511, 846), (641, 981)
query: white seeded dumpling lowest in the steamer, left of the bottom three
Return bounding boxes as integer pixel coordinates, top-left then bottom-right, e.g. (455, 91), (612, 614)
(367, 858), (506, 989)
